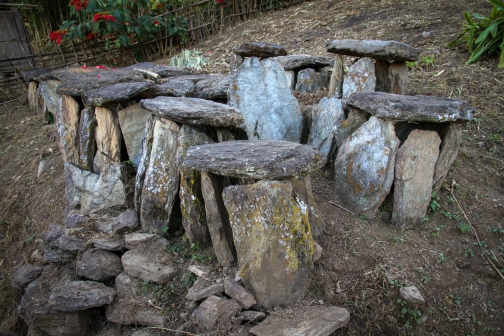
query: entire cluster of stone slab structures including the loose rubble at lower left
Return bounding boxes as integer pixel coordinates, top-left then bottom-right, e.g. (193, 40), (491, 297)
(16, 40), (471, 335)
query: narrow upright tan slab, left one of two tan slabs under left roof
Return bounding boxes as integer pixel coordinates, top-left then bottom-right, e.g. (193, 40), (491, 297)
(55, 96), (80, 164)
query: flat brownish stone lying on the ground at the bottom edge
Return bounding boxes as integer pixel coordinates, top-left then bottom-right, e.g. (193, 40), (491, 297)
(250, 306), (350, 336)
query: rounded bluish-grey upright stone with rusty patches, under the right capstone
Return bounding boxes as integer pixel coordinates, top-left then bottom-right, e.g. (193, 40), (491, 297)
(334, 117), (399, 218)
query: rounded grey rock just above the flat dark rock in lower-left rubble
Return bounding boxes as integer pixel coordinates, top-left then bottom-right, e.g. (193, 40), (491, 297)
(76, 248), (122, 281)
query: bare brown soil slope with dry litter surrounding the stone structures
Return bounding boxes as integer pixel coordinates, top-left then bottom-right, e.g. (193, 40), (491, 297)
(0, 0), (504, 335)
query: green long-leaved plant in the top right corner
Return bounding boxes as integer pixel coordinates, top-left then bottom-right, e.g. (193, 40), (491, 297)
(448, 0), (504, 68)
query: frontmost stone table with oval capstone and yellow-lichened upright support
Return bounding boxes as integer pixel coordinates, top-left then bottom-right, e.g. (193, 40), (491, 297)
(182, 140), (326, 308)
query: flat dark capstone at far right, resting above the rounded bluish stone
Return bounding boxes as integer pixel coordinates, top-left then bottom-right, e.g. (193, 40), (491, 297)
(347, 92), (474, 124)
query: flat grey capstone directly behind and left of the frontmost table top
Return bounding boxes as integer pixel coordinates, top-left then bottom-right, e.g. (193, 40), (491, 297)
(140, 97), (243, 127)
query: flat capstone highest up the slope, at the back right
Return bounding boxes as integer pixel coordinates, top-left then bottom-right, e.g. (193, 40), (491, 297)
(326, 40), (420, 61)
